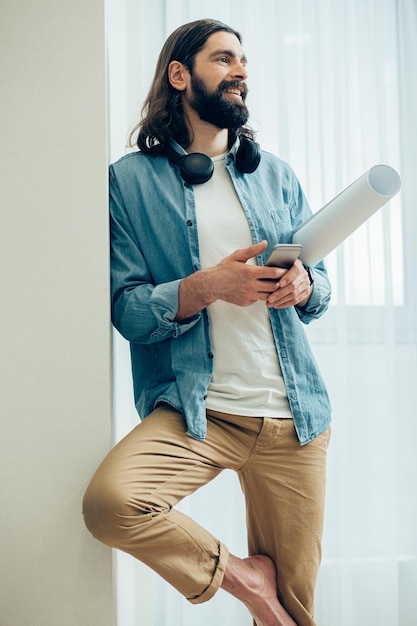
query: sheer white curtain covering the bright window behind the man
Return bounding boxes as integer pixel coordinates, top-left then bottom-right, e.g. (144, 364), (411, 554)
(107, 0), (417, 626)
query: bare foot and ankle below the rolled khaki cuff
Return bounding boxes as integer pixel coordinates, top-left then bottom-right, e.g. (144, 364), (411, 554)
(222, 554), (297, 626)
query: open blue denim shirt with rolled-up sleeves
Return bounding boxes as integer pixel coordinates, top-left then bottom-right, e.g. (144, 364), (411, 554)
(110, 144), (330, 444)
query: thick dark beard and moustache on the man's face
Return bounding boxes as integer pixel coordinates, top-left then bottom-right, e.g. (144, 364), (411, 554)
(190, 74), (249, 130)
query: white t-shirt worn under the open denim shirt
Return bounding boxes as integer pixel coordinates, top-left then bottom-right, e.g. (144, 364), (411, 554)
(194, 155), (291, 418)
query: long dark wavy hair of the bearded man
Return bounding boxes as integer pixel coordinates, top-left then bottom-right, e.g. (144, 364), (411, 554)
(129, 19), (254, 155)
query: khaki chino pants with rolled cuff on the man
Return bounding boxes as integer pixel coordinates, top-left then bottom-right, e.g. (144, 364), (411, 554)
(83, 405), (329, 626)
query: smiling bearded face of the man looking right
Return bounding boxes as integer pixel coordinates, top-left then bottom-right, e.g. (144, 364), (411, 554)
(185, 31), (249, 128)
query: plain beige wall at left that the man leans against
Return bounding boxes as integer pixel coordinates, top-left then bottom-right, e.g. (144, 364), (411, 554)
(0, 0), (113, 626)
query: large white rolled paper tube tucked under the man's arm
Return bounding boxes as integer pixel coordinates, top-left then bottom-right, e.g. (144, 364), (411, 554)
(292, 165), (401, 266)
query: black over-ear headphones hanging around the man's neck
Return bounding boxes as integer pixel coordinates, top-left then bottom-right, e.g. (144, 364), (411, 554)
(164, 136), (261, 185)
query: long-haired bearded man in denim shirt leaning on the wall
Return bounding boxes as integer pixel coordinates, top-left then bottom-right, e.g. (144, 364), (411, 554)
(84, 20), (330, 626)
